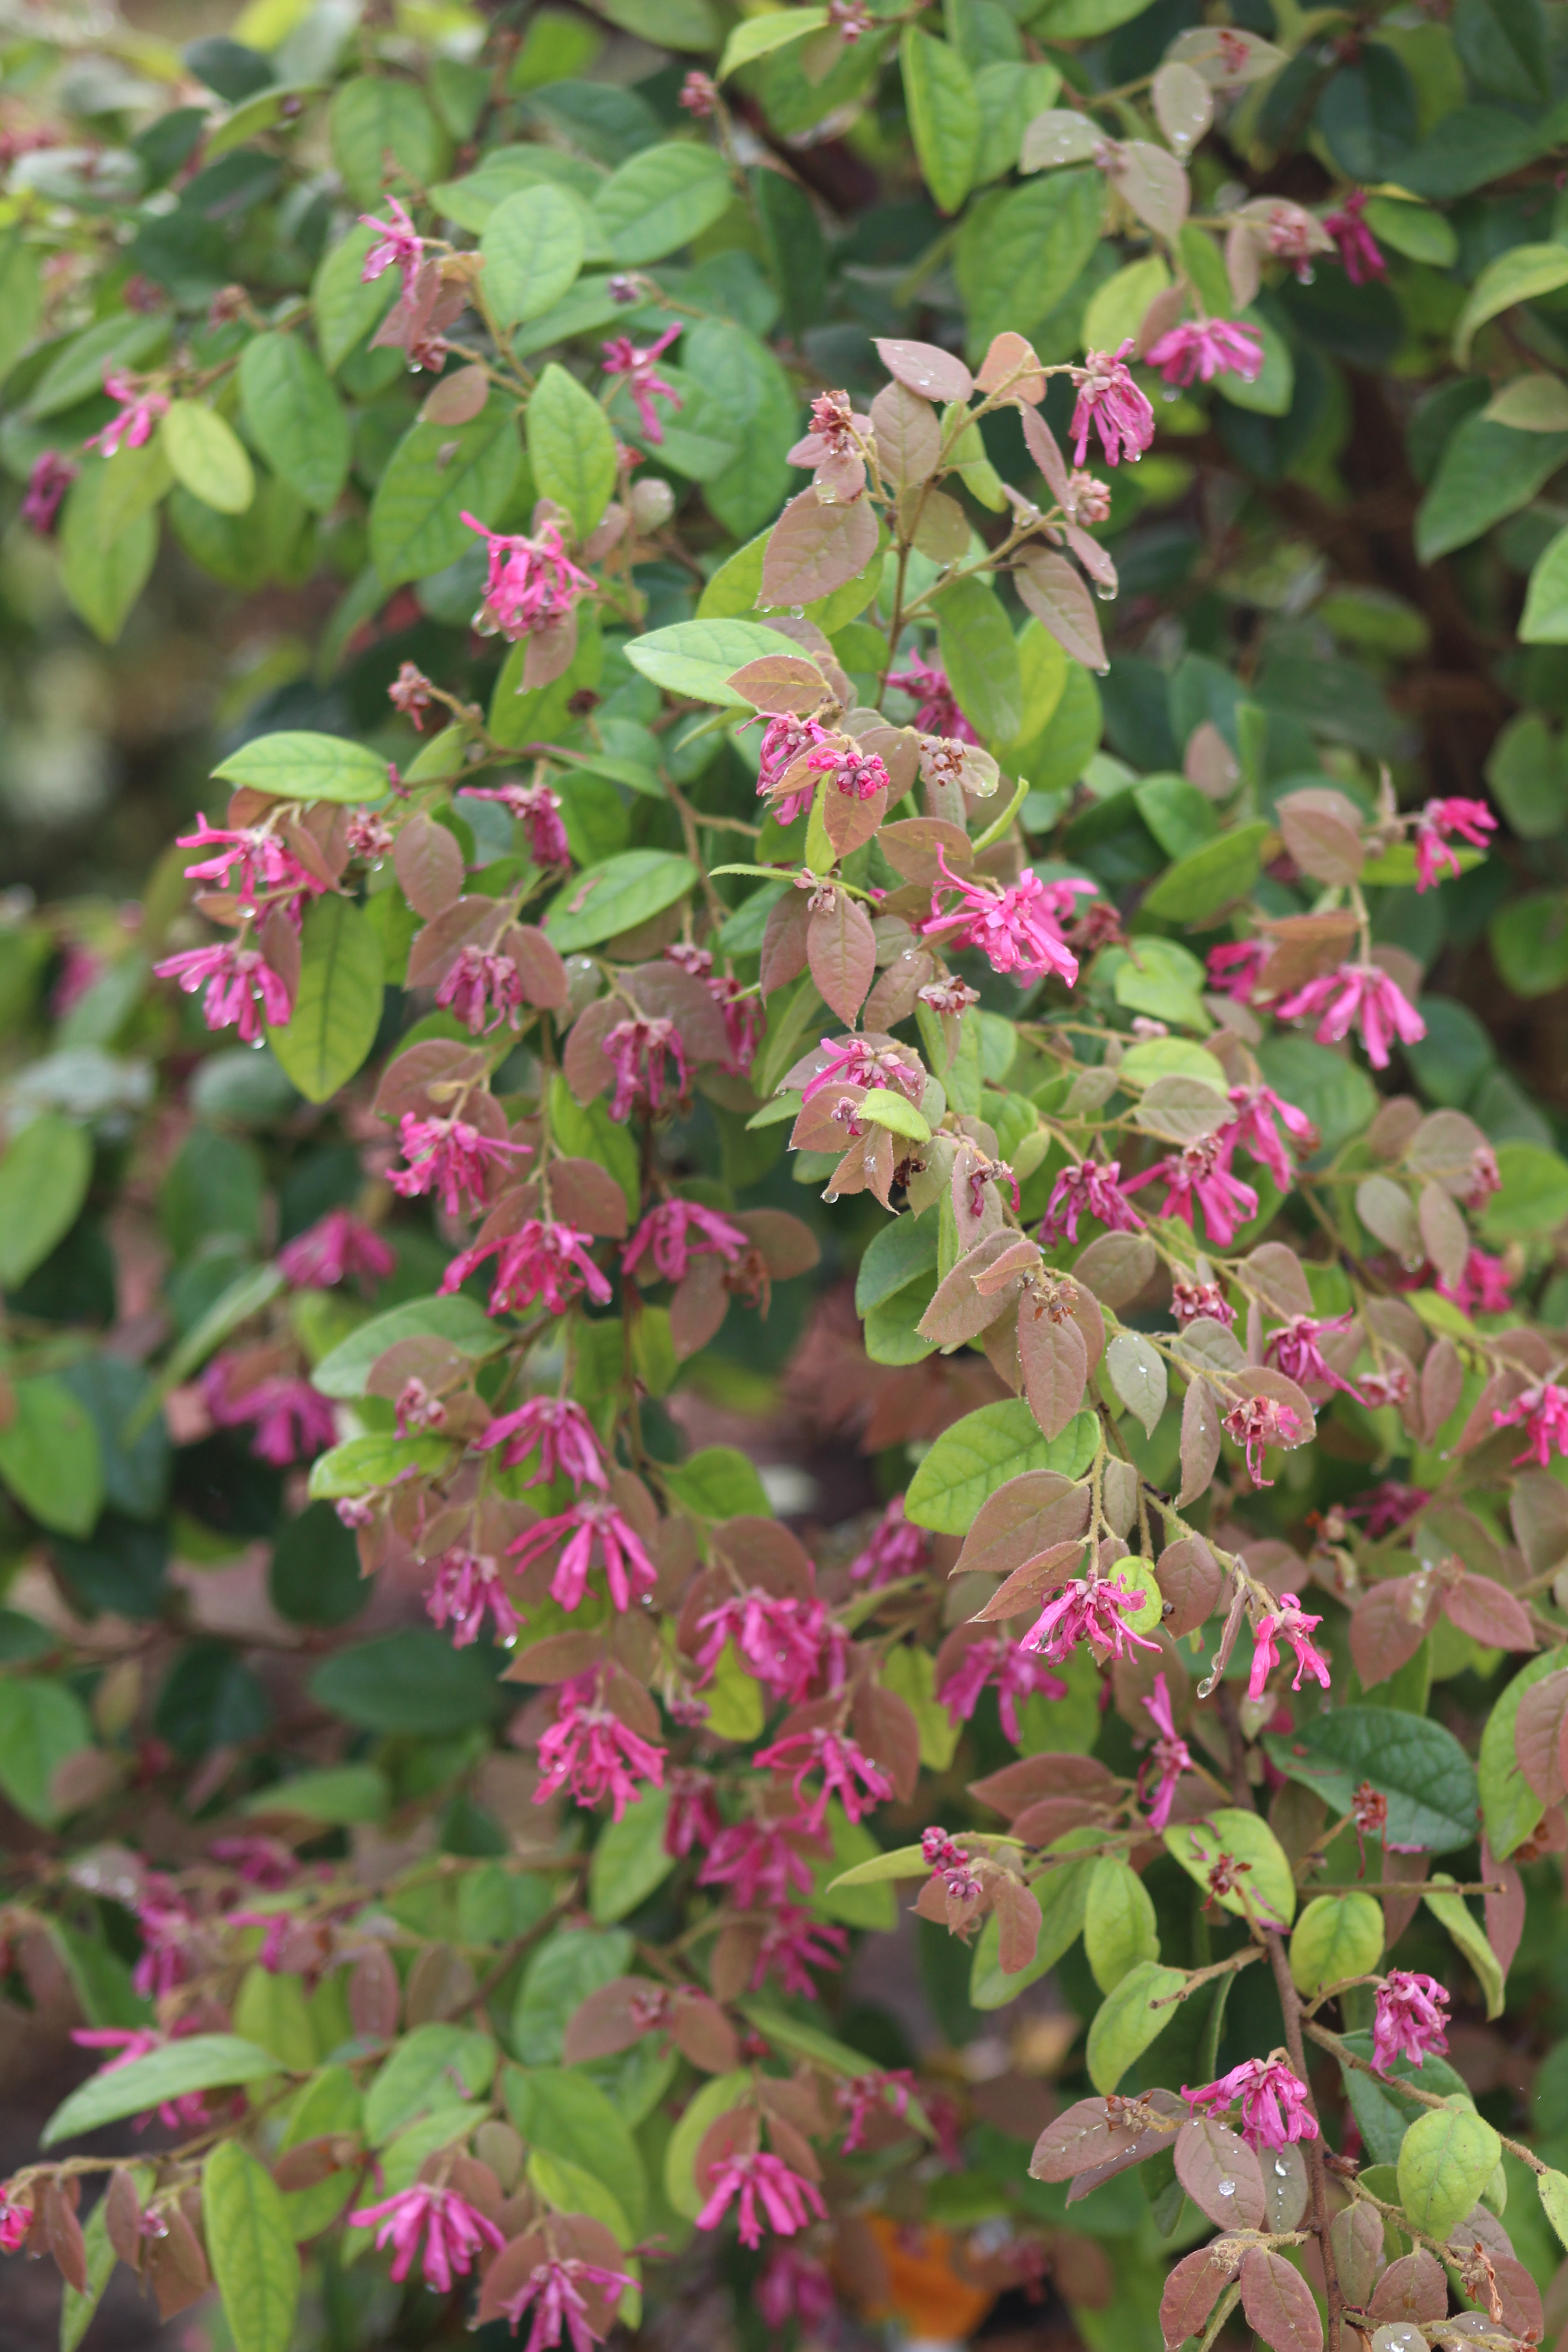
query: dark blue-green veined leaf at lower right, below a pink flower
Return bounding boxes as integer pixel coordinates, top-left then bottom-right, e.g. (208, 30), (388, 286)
(1265, 1708), (1479, 1853)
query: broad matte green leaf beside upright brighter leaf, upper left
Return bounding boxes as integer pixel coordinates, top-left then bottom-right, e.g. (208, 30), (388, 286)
(369, 393), (517, 590)
